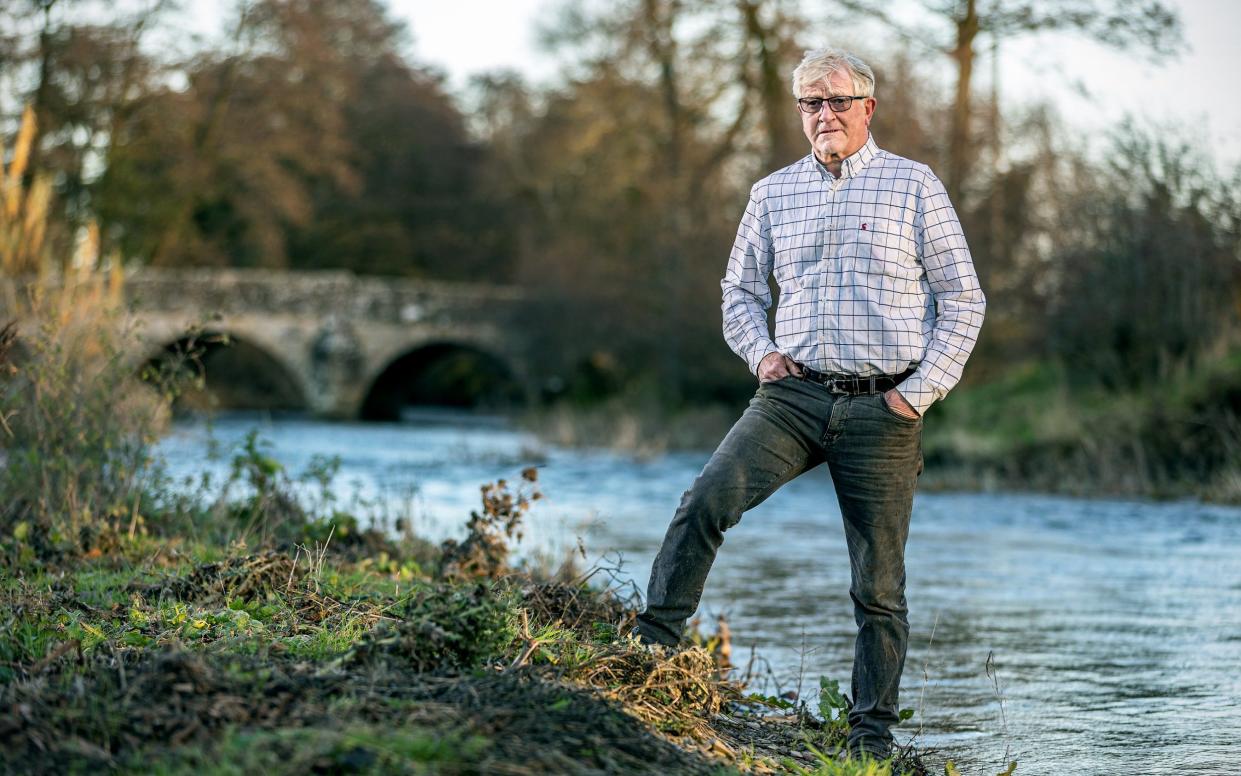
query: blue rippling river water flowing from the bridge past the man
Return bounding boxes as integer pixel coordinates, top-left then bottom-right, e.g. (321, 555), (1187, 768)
(161, 413), (1241, 774)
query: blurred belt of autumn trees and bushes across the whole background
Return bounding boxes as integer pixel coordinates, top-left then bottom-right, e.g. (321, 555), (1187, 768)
(9, 0), (1241, 449)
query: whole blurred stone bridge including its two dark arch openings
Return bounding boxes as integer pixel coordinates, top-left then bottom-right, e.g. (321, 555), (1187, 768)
(125, 269), (537, 418)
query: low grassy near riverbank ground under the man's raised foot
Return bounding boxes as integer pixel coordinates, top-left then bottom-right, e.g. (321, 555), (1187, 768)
(0, 466), (926, 775)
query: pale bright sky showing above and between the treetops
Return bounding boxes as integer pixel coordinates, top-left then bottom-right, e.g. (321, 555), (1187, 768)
(388, 0), (1241, 165)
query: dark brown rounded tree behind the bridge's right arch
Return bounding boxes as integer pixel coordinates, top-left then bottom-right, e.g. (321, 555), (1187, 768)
(290, 47), (514, 281)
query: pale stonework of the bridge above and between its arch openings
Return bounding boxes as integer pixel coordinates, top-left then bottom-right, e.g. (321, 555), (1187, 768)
(124, 268), (535, 418)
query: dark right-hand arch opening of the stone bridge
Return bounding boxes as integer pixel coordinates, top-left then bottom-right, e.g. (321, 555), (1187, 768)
(360, 340), (524, 421)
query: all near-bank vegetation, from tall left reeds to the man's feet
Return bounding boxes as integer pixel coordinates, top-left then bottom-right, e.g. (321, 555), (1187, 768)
(0, 117), (951, 776)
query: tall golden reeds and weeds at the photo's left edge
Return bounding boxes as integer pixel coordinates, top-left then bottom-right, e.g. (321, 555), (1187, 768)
(0, 106), (186, 551)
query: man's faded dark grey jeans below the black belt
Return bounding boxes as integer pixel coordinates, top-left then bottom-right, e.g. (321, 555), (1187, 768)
(638, 377), (922, 752)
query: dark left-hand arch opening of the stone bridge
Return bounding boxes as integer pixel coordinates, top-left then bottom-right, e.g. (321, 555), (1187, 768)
(146, 329), (310, 412)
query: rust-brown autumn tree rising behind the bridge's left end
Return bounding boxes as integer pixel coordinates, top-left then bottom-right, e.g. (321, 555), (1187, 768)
(99, 0), (351, 267)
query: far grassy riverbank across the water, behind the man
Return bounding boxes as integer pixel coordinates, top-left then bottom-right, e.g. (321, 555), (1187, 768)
(521, 351), (1241, 504)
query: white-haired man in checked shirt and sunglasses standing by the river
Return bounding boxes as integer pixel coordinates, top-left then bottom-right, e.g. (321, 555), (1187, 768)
(637, 50), (985, 757)
